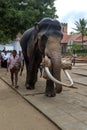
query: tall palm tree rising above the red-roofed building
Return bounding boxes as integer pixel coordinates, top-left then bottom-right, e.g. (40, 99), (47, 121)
(73, 18), (87, 47)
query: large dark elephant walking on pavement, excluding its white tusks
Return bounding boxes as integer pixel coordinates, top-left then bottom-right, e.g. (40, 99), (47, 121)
(20, 17), (73, 97)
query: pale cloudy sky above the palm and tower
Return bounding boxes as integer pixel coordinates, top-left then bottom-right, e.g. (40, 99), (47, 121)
(55, 0), (87, 34)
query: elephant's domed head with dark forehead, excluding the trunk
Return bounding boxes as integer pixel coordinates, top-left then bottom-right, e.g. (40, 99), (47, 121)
(35, 18), (63, 54)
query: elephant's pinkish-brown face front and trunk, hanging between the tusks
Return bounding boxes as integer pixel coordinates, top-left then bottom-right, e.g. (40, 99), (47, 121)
(45, 36), (62, 92)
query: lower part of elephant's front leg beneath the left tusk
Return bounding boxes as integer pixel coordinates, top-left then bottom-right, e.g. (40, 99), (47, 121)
(45, 80), (56, 97)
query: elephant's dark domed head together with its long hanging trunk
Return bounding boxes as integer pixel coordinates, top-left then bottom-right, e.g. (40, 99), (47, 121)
(35, 18), (73, 92)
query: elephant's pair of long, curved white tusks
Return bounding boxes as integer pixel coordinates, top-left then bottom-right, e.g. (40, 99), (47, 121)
(44, 67), (73, 87)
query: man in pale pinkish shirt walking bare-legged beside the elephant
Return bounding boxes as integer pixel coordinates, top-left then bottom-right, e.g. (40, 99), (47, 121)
(7, 50), (21, 88)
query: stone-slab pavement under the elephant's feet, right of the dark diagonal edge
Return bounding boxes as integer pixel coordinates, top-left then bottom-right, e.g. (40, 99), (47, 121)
(0, 64), (87, 130)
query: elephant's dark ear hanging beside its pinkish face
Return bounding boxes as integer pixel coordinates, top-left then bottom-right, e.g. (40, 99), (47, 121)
(38, 35), (48, 53)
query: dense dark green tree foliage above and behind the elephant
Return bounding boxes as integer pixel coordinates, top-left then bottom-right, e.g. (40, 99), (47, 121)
(0, 0), (58, 43)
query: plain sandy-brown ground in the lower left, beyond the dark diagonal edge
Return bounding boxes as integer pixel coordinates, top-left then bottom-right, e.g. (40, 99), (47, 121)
(0, 79), (58, 130)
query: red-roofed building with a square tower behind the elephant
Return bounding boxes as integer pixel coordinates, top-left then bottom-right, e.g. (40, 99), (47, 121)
(61, 23), (87, 54)
